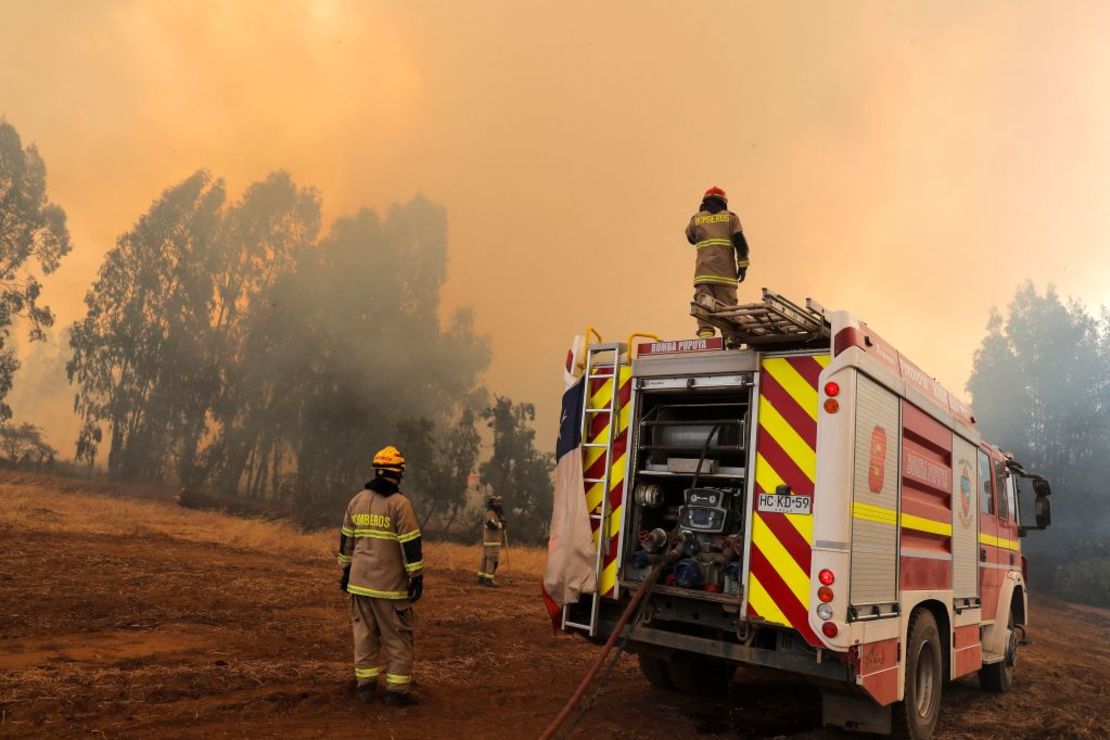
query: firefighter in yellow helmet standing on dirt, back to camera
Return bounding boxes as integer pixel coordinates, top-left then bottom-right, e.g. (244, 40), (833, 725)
(339, 446), (424, 706)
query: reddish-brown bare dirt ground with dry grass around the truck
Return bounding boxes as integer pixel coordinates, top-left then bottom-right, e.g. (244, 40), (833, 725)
(0, 474), (1110, 738)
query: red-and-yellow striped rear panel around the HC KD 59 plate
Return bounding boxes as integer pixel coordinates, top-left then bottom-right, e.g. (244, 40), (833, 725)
(748, 355), (829, 647)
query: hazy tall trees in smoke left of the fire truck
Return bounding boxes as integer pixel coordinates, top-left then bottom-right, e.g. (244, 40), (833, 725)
(0, 117), (552, 540)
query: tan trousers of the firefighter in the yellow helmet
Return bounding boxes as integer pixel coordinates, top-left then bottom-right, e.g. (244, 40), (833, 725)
(351, 594), (413, 693)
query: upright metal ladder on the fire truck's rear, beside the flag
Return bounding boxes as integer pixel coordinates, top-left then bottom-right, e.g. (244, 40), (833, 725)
(563, 342), (628, 637)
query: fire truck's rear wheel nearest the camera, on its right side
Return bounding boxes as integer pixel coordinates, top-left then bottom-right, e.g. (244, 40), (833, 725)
(891, 609), (945, 740)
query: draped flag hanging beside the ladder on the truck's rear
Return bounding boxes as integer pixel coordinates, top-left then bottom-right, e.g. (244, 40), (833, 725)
(541, 336), (597, 630)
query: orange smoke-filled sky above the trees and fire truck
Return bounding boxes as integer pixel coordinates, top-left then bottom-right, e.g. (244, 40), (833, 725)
(0, 0), (1110, 450)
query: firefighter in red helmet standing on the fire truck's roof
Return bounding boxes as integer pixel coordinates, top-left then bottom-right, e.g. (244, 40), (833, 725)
(686, 186), (748, 337)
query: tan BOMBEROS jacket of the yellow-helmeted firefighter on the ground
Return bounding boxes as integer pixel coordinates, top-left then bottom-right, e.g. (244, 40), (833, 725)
(339, 478), (424, 599)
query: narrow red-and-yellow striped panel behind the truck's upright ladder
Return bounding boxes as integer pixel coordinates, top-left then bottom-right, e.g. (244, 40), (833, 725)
(583, 366), (632, 598)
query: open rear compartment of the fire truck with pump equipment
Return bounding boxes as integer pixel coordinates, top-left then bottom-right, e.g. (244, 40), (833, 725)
(623, 382), (751, 603)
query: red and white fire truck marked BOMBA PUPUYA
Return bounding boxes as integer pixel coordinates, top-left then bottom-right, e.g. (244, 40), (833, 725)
(563, 290), (1051, 738)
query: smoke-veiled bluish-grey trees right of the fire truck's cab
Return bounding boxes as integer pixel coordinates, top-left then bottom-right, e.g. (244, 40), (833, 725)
(968, 283), (1110, 606)
